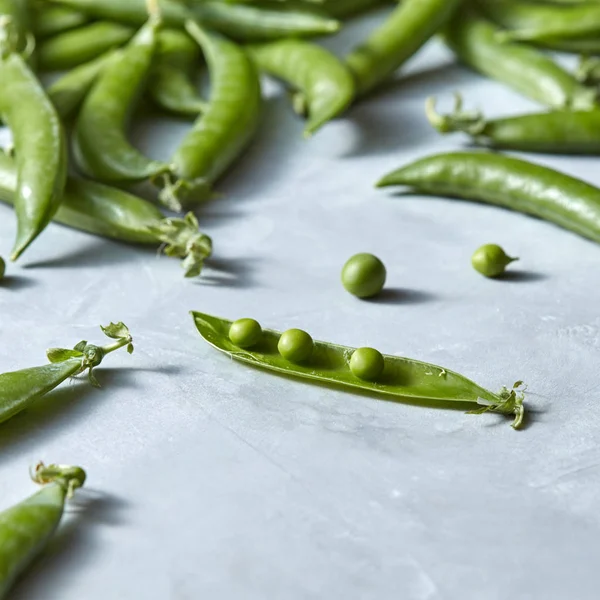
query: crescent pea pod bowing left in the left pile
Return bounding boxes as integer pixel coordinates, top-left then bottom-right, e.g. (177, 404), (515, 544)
(73, 19), (166, 183)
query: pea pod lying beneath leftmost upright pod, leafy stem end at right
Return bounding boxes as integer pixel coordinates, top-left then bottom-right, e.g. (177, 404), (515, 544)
(0, 152), (212, 277)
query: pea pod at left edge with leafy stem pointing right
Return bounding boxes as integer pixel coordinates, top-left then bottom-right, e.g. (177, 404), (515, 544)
(0, 323), (133, 423)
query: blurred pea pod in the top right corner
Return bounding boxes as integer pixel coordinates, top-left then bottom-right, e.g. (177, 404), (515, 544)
(479, 0), (600, 41)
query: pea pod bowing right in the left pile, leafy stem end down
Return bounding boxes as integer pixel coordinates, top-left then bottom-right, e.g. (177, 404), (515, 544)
(156, 21), (261, 210)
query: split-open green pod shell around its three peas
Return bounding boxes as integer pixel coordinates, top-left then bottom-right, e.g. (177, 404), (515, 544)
(192, 312), (524, 428)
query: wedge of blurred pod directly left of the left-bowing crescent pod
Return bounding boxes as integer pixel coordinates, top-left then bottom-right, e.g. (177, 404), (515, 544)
(46, 50), (118, 121)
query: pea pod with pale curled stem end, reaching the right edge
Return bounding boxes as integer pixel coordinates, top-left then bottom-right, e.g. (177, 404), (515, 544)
(426, 96), (600, 155)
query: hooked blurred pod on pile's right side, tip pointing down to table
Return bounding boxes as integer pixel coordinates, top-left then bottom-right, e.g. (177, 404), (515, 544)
(248, 40), (355, 136)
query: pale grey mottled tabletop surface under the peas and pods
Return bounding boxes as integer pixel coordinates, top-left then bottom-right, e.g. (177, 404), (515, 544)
(0, 10), (600, 600)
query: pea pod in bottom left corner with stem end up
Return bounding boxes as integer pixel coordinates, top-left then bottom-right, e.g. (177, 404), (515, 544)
(0, 463), (86, 598)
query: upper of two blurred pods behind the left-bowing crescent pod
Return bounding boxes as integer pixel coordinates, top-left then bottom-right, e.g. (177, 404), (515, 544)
(37, 21), (135, 71)
